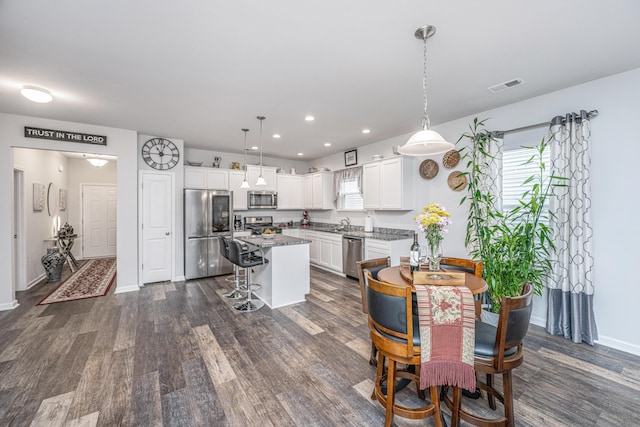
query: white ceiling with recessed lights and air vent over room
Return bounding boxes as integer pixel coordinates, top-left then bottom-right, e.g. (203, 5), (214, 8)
(0, 0), (640, 160)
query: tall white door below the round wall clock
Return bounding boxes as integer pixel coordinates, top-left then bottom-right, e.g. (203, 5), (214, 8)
(142, 173), (174, 283)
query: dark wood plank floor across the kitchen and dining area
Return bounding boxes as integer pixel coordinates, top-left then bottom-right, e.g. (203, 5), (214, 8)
(0, 269), (640, 426)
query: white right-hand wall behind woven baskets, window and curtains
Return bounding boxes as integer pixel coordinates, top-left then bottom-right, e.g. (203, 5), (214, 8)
(312, 69), (640, 355)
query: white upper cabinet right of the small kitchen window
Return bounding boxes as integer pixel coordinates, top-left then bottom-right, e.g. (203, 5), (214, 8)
(362, 156), (413, 210)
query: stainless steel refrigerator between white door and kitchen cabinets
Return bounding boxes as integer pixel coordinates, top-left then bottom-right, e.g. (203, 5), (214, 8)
(184, 190), (233, 279)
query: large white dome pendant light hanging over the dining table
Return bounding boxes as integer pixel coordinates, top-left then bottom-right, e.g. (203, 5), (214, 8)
(398, 25), (454, 156)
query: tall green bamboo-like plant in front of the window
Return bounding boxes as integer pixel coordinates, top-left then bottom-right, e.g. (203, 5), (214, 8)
(458, 118), (564, 312)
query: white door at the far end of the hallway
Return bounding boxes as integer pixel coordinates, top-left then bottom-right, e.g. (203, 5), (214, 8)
(82, 185), (117, 259)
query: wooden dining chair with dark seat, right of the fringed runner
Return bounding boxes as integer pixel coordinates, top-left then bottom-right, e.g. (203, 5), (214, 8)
(442, 282), (533, 427)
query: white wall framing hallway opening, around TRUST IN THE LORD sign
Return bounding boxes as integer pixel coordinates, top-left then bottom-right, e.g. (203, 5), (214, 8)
(0, 114), (139, 310)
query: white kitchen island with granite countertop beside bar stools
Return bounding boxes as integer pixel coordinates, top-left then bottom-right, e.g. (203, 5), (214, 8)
(238, 234), (311, 308)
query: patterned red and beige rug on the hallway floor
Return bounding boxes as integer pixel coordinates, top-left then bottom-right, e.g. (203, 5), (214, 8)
(38, 258), (116, 305)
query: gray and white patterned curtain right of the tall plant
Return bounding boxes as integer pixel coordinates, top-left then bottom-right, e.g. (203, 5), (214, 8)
(547, 111), (598, 345)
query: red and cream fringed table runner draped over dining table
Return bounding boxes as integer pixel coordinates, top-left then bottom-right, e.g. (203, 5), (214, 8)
(414, 284), (476, 391)
